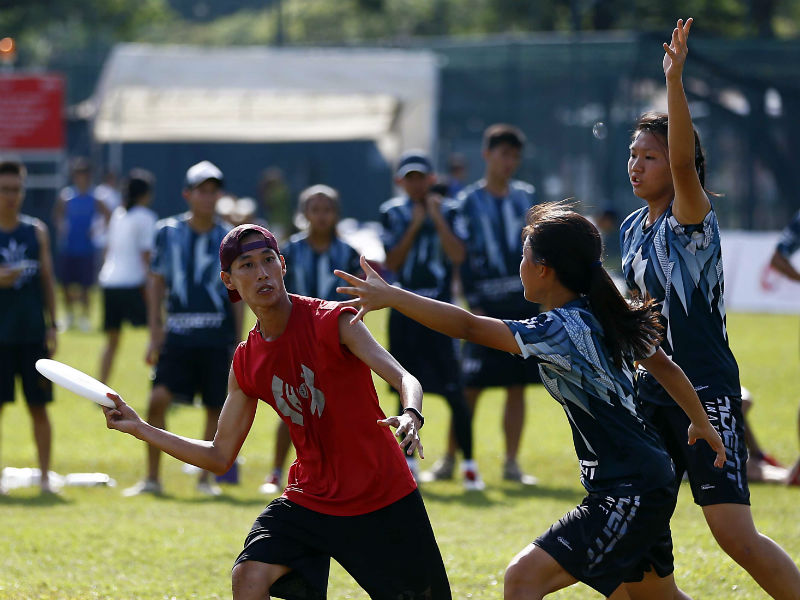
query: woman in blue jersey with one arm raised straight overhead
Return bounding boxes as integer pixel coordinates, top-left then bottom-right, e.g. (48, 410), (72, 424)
(621, 19), (800, 599)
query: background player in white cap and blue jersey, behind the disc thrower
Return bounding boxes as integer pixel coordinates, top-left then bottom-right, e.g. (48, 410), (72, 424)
(123, 161), (242, 496)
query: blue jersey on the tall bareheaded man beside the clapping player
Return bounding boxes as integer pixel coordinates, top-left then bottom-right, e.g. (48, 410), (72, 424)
(456, 179), (537, 317)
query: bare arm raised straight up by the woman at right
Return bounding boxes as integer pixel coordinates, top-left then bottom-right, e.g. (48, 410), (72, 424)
(664, 19), (711, 225)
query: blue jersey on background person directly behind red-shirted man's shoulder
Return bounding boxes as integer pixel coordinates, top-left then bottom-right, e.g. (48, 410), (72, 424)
(281, 231), (361, 300)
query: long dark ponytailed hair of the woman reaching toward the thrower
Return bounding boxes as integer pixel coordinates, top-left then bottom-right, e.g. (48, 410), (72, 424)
(522, 202), (663, 367)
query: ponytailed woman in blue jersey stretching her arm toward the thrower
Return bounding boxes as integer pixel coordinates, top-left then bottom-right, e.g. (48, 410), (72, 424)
(337, 204), (725, 600)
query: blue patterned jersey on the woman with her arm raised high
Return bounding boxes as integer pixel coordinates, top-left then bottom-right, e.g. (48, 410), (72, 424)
(621, 205), (741, 404)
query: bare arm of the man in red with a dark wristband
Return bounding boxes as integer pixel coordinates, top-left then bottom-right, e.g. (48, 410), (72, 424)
(339, 313), (425, 458)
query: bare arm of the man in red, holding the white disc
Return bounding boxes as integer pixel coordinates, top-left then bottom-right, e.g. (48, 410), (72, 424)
(103, 368), (258, 475)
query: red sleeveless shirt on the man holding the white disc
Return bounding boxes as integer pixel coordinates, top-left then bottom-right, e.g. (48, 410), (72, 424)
(233, 294), (417, 515)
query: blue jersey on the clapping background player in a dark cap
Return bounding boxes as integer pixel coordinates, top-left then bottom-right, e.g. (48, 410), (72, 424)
(380, 196), (464, 302)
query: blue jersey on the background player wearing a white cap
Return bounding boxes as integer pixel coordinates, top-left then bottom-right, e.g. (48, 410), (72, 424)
(150, 213), (234, 346)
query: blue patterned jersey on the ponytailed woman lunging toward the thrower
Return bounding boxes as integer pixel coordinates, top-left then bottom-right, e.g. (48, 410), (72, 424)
(505, 298), (674, 495)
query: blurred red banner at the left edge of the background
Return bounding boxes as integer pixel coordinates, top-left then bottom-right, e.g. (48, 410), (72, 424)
(0, 74), (64, 150)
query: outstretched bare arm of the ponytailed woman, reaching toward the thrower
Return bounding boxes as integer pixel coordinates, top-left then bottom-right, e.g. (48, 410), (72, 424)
(334, 256), (520, 354)
